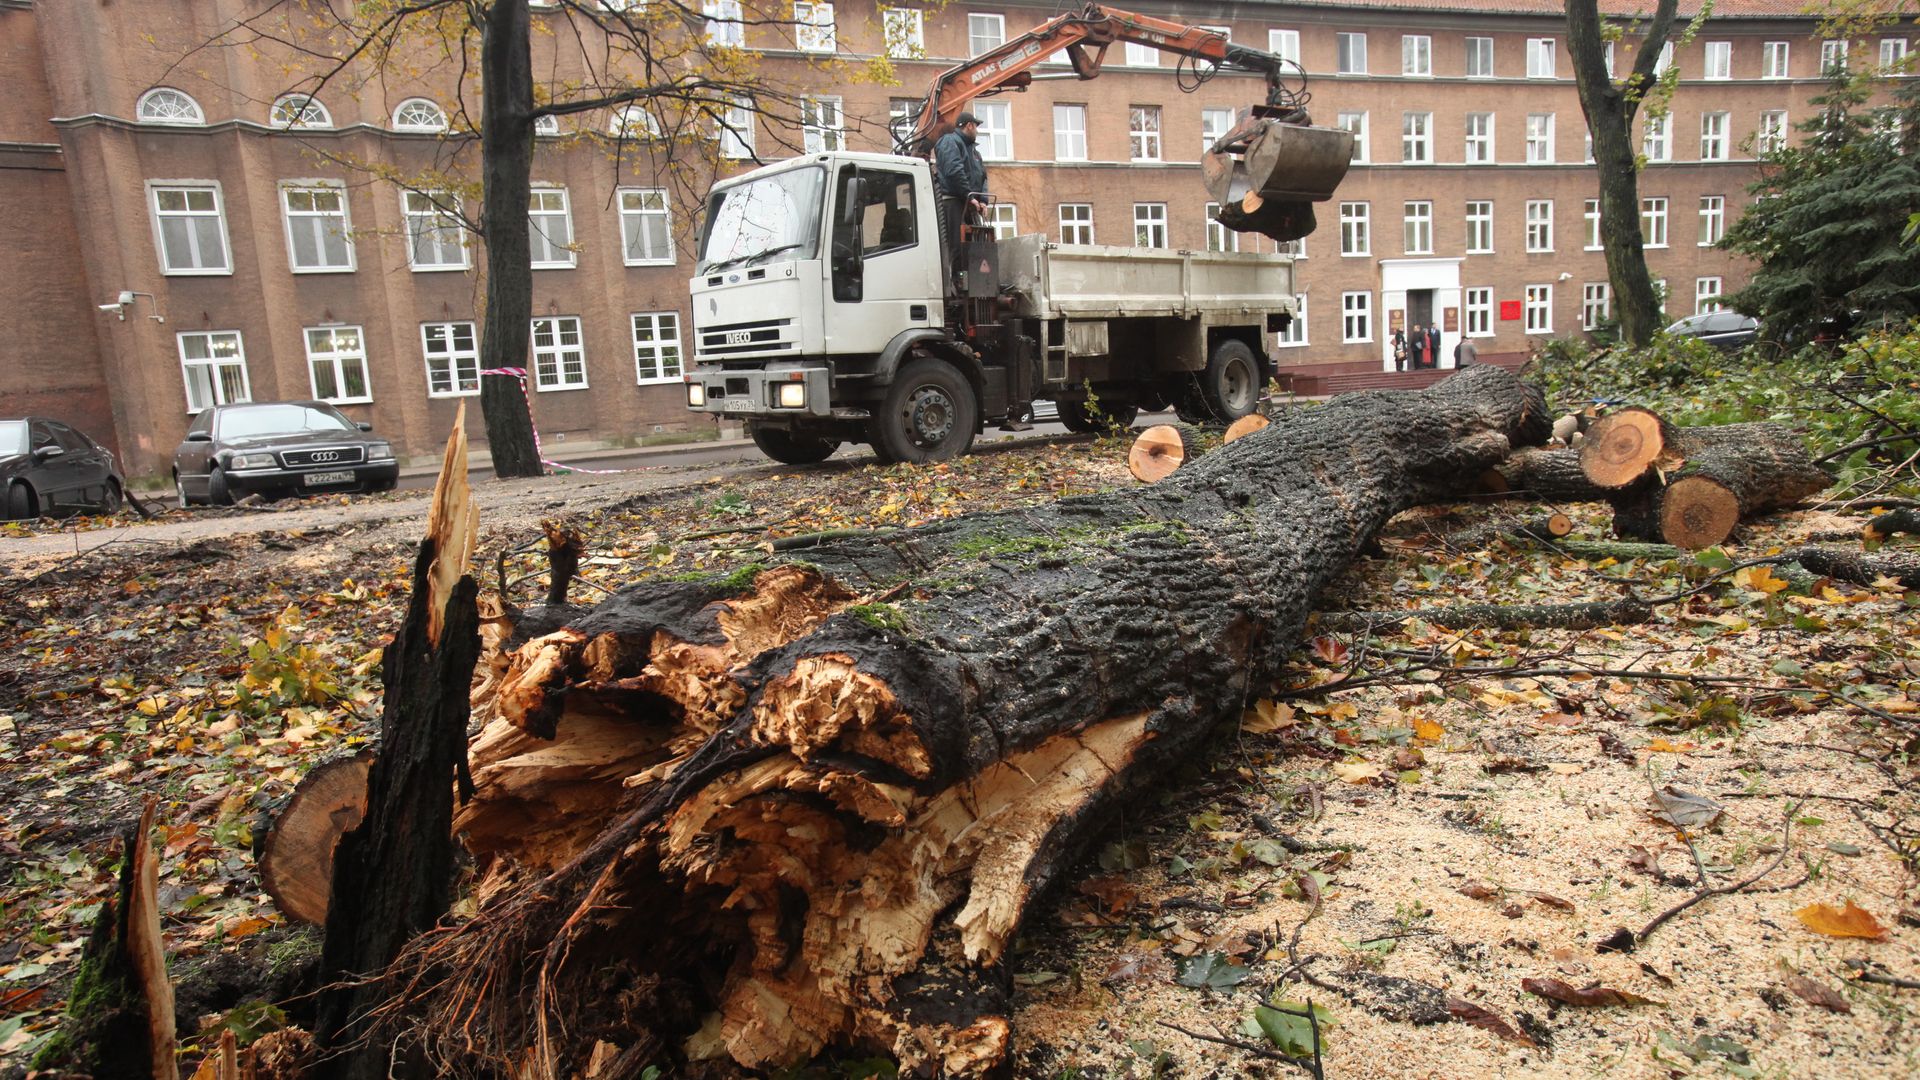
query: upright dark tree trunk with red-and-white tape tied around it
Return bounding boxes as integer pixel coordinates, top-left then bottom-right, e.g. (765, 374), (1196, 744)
(480, 0), (545, 477)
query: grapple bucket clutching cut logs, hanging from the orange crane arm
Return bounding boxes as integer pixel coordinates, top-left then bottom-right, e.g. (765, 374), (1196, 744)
(1200, 110), (1354, 240)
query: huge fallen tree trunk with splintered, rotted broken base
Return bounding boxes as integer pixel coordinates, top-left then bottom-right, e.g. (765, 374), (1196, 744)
(366, 367), (1549, 1076)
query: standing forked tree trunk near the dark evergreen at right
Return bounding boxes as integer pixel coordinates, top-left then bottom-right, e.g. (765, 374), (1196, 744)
(1567, 0), (1680, 346)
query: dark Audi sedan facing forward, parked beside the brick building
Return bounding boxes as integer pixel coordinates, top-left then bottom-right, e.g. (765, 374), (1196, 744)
(173, 402), (399, 505)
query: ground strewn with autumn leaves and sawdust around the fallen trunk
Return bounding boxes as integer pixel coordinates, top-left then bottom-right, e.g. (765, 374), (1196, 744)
(0, 432), (1920, 1080)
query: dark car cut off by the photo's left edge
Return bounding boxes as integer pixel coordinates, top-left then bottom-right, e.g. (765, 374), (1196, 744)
(0, 417), (127, 521)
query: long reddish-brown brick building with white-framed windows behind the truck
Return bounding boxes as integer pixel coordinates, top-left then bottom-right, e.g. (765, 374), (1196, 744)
(0, 0), (1907, 477)
